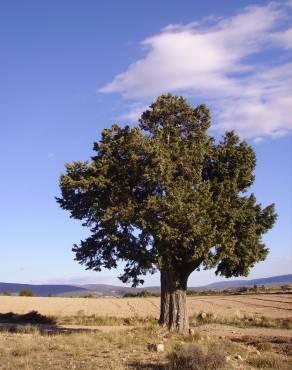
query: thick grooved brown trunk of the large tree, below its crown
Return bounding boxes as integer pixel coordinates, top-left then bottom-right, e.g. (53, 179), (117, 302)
(159, 269), (189, 334)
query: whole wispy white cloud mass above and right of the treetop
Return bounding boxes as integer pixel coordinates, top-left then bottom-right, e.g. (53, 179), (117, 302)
(100, 2), (292, 137)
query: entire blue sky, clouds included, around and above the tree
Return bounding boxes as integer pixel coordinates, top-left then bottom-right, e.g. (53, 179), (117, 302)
(0, 0), (292, 285)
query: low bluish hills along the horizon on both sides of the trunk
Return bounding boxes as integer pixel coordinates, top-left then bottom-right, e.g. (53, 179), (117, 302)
(0, 274), (292, 297)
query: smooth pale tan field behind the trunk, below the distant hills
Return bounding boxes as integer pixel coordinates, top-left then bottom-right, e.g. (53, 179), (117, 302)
(0, 294), (292, 318)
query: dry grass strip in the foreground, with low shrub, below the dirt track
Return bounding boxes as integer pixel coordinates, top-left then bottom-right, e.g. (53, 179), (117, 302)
(0, 324), (292, 370)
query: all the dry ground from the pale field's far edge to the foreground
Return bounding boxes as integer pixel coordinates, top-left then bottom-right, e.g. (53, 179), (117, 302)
(0, 294), (292, 370)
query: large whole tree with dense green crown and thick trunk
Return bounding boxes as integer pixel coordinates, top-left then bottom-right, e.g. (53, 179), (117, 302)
(57, 95), (276, 333)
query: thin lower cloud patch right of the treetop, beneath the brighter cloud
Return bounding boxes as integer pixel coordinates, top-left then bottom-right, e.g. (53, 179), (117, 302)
(215, 63), (292, 138)
